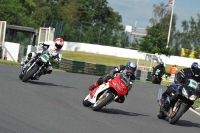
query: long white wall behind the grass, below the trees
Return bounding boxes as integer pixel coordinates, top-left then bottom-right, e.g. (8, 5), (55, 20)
(63, 42), (200, 67)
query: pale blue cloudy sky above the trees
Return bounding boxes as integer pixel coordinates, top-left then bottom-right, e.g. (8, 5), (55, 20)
(107, 0), (200, 32)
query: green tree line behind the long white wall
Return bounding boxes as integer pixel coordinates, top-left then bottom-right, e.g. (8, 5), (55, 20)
(0, 0), (200, 58)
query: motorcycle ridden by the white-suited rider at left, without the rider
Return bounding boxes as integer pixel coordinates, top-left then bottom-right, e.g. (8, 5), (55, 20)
(19, 50), (58, 82)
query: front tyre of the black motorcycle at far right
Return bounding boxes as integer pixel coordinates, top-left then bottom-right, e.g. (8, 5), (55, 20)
(169, 104), (187, 124)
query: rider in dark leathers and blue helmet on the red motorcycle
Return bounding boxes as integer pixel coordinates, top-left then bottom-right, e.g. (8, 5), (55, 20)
(89, 61), (137, 103)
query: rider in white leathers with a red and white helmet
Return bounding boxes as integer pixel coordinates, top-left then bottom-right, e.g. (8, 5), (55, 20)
(21, 38), (64, 80)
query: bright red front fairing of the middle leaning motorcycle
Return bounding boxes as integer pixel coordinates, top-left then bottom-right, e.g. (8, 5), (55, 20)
(109, 73), (128, 95)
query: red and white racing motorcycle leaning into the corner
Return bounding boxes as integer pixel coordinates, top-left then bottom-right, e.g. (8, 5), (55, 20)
(82, 73), (130, 111)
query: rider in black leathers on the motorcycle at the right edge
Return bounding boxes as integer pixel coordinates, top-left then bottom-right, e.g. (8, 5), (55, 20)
(161, 62), (200, 104)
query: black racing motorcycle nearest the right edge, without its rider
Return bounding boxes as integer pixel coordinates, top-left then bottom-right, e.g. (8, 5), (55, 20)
(157, 79), (199, 124)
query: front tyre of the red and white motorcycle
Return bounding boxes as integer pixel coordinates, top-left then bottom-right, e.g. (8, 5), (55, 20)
(92, 91), (113, 111)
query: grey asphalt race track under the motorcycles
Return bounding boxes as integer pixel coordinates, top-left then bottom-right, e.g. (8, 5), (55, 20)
(0, 65), (200, 133)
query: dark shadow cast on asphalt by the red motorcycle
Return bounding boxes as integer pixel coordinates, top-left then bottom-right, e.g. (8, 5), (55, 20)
(98, 108), (148, 116)
